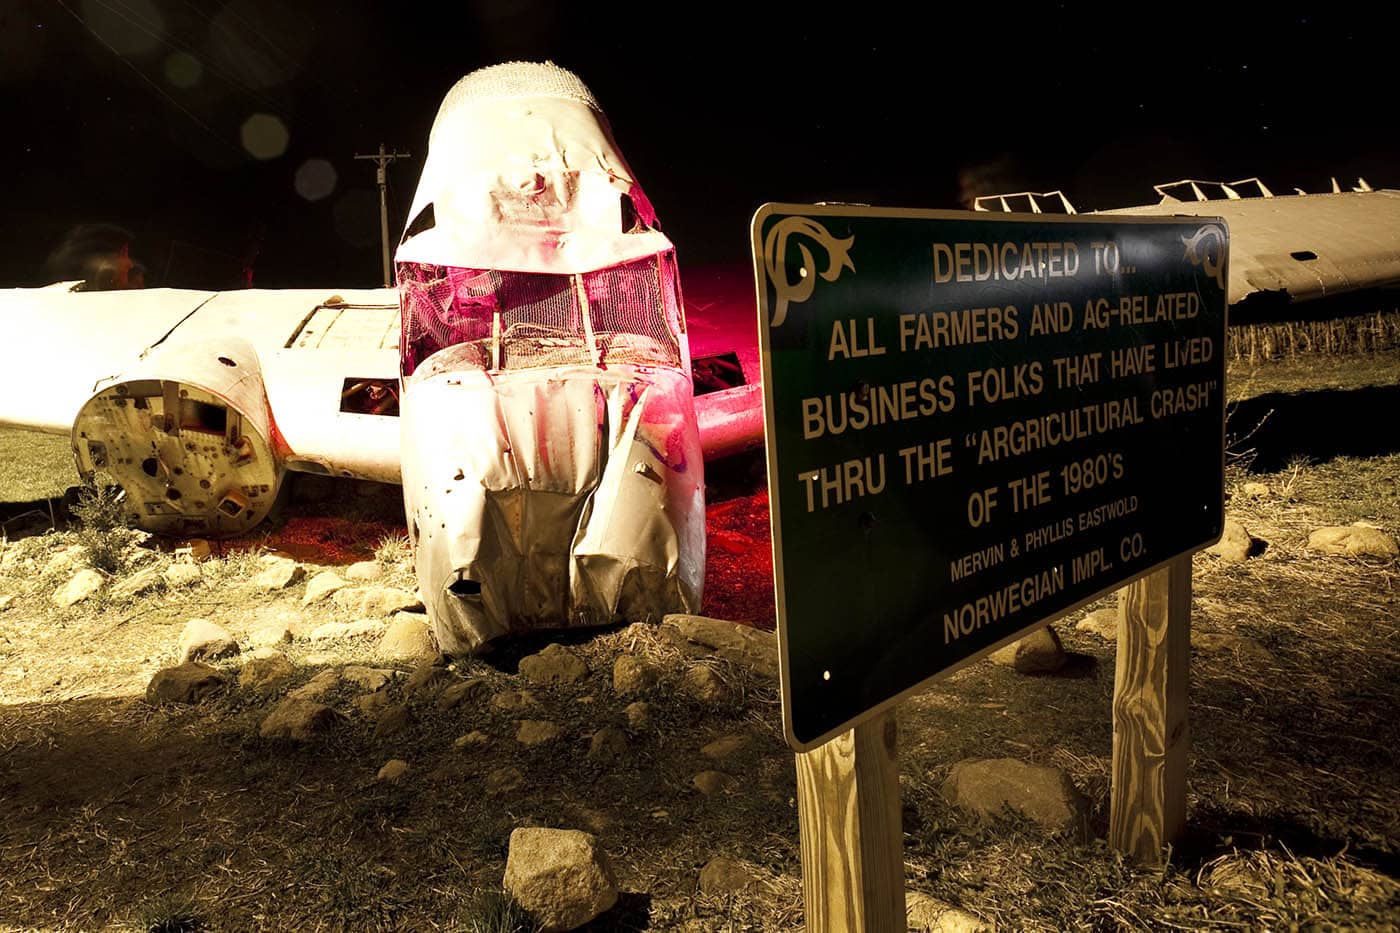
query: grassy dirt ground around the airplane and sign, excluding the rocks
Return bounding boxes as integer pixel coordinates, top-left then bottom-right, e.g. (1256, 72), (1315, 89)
(0, 353), (1400, 930)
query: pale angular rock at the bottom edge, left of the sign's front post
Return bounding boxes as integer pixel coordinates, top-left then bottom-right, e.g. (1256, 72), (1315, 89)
(504, 828), (617, 932)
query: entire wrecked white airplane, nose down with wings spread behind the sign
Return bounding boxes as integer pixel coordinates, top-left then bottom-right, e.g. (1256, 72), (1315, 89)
(0, 63), (1400, 654)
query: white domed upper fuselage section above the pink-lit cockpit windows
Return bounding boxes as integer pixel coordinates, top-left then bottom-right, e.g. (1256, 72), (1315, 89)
(396, 62), (671, 275)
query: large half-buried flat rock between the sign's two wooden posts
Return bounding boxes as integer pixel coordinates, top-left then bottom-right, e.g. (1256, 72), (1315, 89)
(942, 758), (1089, 842)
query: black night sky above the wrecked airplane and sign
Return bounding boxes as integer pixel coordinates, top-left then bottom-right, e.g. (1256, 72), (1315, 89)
(0, 0), (1400, 287)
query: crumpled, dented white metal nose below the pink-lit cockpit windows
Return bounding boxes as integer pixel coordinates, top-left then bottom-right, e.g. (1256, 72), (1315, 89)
(402, 347), (704, 654)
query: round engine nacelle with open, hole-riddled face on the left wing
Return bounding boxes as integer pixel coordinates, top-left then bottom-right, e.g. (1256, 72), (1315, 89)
(73, 338), (286, 537)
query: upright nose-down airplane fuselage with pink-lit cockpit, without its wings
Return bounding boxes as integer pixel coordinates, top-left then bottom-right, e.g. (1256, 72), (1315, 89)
(396, 62), (706, 654)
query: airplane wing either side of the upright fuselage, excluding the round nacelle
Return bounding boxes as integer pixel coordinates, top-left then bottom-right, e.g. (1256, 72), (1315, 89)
(0, 273), (763, 483)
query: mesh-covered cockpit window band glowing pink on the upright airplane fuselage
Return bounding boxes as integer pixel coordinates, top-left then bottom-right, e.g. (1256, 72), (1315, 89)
(399, 249), (686, 377)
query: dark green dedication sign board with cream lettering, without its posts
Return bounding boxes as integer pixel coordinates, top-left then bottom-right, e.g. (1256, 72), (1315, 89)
(752, 205), (1228, 751)
